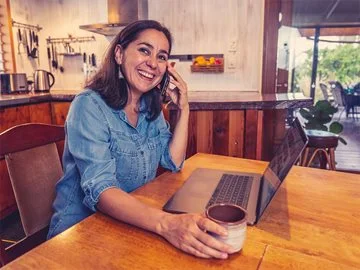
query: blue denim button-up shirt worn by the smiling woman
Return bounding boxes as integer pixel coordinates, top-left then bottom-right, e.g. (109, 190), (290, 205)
(48, 89), (182, 238)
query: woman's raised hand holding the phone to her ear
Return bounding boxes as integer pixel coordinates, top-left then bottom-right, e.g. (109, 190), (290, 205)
(166, 63), (189, 110)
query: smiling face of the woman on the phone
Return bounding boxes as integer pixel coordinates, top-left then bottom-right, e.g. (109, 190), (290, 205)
(115, 29), (169, 95)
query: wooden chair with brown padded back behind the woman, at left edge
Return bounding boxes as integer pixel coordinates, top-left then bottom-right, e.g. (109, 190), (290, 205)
(0, 123), (65, 265)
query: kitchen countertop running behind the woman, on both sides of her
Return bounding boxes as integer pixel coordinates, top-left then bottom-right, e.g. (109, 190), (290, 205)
(0, 90), (312, 110)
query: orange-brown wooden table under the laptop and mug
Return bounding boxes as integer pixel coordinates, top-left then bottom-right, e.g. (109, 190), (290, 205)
(4, 154), (360, 269)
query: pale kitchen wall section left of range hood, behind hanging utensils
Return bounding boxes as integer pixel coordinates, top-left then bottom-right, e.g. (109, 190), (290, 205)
(11, 0), (109, 90)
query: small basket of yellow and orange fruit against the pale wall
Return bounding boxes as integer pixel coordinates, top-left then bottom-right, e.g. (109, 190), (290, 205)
(191, 55), (224, 73)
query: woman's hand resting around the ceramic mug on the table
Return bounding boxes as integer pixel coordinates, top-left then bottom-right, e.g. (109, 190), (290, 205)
(157, 214), (234, 259)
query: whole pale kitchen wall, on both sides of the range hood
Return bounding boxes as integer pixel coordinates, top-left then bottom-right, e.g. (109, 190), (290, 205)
(11, 0), (264, 91)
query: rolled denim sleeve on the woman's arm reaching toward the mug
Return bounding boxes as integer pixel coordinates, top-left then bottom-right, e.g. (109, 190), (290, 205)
(66, 94), (117, 211)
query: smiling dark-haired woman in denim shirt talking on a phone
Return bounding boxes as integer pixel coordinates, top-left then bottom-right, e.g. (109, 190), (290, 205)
(48, 20), (232, 258)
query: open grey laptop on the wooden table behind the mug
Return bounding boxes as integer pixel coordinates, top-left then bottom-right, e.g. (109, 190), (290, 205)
(163, 118), (308, 225)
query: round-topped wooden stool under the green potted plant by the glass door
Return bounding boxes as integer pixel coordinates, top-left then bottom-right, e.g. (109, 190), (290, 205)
(300, 130), (339, 170)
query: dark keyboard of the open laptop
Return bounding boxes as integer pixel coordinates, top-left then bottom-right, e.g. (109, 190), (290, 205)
(206, 174), (253, 209)
